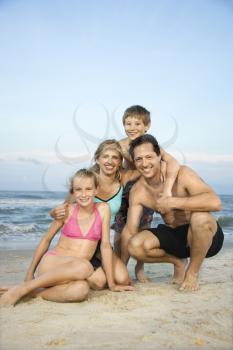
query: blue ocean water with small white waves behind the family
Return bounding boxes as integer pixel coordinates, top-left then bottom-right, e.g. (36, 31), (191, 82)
(0, 191), (233, 249)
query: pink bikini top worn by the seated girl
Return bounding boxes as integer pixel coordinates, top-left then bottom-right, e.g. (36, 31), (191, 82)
(61, 204), (102, 241)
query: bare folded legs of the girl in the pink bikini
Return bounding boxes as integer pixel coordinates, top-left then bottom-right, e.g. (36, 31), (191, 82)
(0, 254), (93, 305)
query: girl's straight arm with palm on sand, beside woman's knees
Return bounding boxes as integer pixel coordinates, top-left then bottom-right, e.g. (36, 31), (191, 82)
(98, 203), (133, 292)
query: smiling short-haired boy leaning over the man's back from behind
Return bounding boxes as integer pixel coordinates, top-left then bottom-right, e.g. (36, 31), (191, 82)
(114, 105), (180, 282)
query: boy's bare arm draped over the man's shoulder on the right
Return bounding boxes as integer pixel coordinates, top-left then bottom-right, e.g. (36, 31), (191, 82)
(160, 148), (180, 197)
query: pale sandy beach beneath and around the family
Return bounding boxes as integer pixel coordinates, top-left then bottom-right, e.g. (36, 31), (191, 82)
(0, 237), (233, 350)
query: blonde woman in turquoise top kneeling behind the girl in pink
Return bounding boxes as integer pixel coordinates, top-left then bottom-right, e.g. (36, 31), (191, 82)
(50, 139), (139, 289)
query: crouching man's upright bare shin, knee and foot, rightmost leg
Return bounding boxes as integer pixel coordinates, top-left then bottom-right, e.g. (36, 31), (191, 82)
(180, 213), (217, 291)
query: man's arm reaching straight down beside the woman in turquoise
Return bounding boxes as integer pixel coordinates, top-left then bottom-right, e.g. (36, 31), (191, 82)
(121, 189), (143, 265)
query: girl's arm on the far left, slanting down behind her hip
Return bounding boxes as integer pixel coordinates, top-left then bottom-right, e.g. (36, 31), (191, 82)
(24, 220), (64, 281)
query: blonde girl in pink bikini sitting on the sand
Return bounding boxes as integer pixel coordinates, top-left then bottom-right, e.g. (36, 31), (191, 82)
(0, 169), (133, 305)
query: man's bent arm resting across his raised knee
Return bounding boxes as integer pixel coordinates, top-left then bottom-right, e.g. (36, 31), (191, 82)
(157, 166), (221, 212)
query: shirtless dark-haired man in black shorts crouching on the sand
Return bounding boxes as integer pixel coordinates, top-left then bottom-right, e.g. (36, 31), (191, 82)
(121, 134), (224, 291)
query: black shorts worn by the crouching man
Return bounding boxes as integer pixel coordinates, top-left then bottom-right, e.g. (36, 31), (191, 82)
(147, 222), (224, 258)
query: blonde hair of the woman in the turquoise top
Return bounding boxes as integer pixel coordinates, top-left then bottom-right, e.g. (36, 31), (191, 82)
(91, 139), (123, 181)
